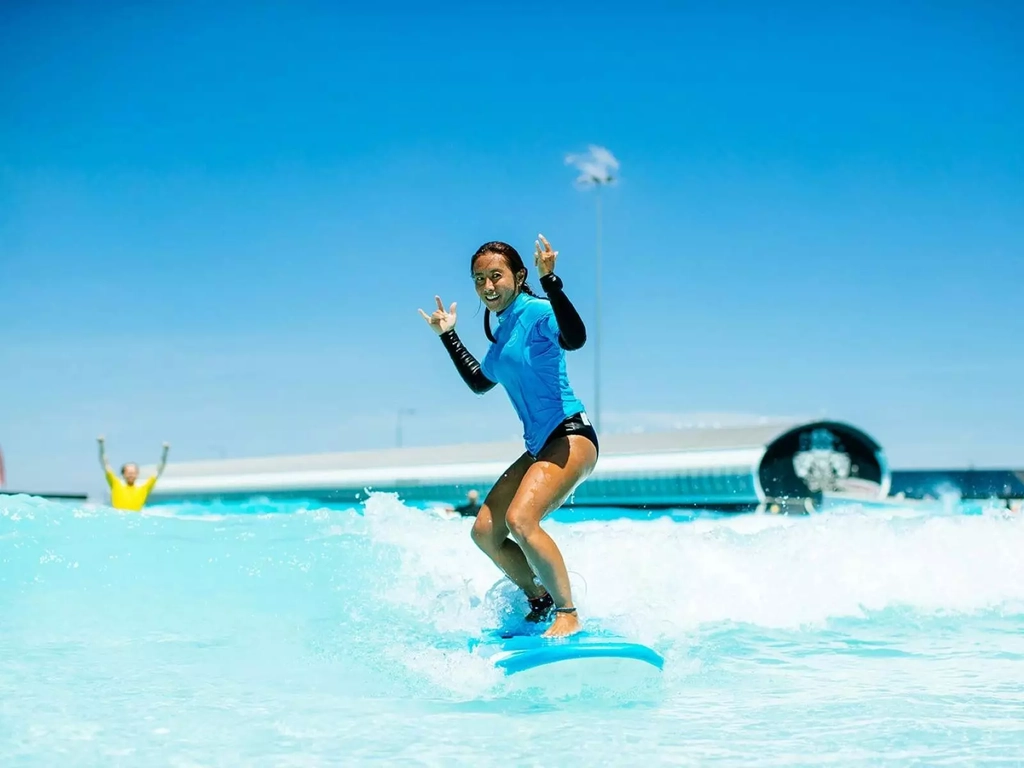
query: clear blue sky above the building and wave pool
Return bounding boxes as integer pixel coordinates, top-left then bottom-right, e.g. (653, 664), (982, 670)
(0, 2), (1024, 490)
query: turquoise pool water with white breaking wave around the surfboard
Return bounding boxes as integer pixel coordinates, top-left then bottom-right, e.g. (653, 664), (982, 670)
(0, 496), (1024, 767)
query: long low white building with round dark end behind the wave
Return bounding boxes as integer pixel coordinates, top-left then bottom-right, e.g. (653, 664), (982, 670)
(143, 420), (891, 510)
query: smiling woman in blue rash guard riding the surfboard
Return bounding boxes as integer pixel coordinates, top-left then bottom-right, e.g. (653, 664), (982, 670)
(420, 234), (598, 637)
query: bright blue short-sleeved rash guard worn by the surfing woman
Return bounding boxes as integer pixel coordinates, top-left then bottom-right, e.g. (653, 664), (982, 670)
(480, 293), (584, 456)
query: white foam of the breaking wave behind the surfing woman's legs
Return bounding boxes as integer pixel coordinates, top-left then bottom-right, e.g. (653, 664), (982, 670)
(356, 496), (1024, 642)
